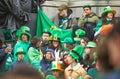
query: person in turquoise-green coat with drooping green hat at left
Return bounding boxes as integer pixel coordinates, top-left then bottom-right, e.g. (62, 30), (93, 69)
(14, 32), (31, 61)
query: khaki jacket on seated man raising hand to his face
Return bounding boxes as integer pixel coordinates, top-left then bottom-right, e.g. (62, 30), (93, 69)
(78, 12), (99, 28)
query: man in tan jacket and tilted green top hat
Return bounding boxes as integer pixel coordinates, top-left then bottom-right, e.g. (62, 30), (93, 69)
(65, 45), (86, 79)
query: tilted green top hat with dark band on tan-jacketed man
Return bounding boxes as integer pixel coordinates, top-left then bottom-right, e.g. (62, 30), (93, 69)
(68, 45), (84, 60)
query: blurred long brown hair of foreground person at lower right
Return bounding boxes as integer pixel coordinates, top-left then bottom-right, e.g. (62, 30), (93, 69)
(97, 40), (113, 72)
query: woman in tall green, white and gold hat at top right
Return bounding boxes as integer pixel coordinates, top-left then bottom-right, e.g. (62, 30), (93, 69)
(95, 6), (116, 36)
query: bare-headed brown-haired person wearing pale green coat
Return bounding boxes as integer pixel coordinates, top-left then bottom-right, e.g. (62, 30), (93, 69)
(28, 36), (42, 69)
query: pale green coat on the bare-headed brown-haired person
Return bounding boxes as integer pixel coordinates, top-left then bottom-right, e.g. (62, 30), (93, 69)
(28, 47), (41, 69)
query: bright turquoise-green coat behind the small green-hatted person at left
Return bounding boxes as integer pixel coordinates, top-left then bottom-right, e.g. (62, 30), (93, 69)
(14, 40), (30, 61)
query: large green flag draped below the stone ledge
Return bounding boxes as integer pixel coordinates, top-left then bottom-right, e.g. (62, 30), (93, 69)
(36, 7), (72, 40)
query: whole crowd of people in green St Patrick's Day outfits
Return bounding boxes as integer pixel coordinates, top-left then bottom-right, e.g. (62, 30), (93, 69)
(0, 4), (120, 79)
